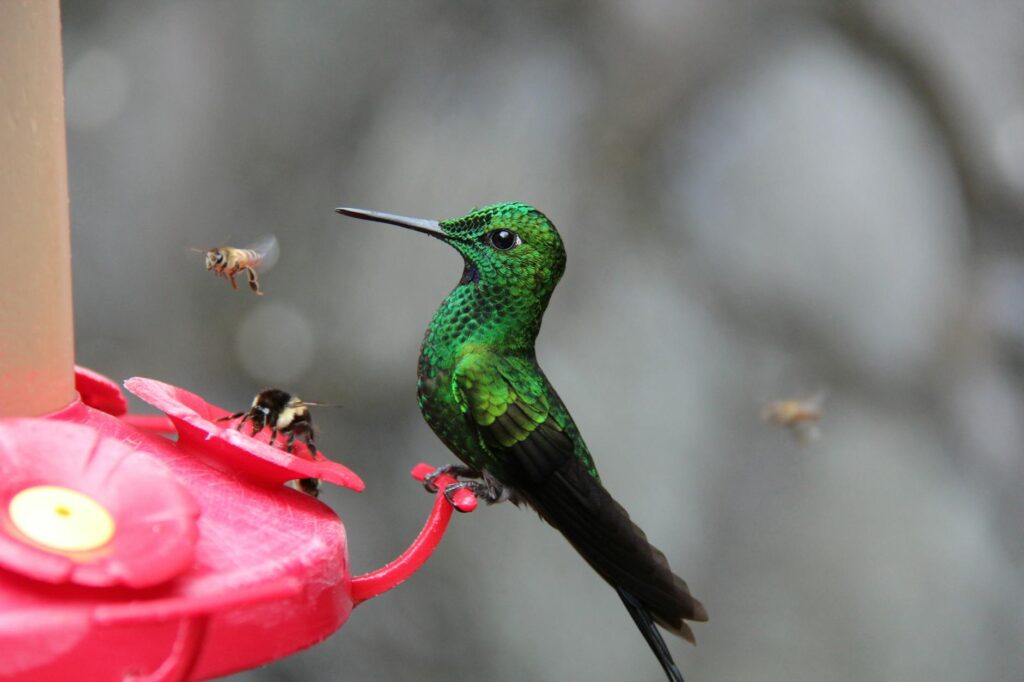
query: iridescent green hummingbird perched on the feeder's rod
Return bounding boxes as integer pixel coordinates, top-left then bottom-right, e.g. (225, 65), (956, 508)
(335, 203), (708, 682)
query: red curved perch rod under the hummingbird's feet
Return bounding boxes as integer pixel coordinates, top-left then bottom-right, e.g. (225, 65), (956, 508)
(352, 464), (476, 605)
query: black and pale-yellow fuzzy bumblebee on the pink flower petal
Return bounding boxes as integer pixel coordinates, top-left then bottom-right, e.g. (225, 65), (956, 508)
(217, 388), (340, 498)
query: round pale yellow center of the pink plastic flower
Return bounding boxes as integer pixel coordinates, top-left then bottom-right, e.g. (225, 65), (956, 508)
(7, 485), (116, 552)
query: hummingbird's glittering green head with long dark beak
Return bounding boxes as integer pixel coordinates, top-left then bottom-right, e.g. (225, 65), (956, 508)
(336, 203), (565, 296)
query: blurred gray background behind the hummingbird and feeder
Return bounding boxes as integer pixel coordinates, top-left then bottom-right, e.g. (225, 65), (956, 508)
(63, 0), (1024, 682)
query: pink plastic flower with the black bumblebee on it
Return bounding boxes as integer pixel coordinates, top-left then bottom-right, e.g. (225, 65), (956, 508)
(125, 377), (366, 492)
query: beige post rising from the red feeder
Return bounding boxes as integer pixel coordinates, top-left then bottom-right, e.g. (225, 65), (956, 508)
(0, 0), (75, 417)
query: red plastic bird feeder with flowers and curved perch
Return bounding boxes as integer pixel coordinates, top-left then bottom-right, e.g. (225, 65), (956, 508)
(0, 370), (476, 682)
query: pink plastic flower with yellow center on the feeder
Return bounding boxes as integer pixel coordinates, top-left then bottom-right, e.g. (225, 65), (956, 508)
(0, 419), (199, 588)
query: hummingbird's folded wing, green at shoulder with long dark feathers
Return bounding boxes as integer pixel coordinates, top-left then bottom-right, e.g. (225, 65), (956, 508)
(453, 354), (708, 651)
